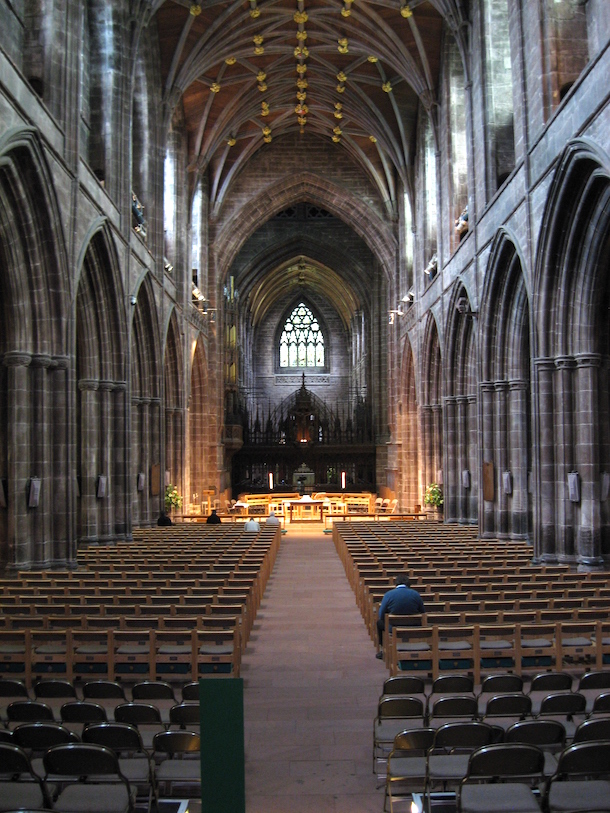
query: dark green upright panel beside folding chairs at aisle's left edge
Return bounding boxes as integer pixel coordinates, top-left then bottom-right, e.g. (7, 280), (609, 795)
(199, 677), (246, 813)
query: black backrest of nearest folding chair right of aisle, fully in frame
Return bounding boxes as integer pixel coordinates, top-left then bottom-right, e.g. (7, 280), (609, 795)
(465, 743), (544, 781)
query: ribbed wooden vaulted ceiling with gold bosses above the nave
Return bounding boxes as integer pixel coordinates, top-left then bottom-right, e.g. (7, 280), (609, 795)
(153, 0), (463, 205)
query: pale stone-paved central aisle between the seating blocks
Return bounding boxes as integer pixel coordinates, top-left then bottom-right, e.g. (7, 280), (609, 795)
(242, 527), (387, 813)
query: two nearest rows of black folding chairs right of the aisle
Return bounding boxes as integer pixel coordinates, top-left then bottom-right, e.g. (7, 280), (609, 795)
(384, 720), (610, 813)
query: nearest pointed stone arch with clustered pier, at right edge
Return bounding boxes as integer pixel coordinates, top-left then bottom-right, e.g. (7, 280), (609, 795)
(535, 141), (610, 567)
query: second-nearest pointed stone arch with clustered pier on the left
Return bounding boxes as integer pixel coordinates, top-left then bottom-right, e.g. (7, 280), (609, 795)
(76, 221), (131, 543)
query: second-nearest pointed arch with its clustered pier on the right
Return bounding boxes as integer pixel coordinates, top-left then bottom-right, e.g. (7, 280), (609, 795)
(479, 230), (532, 539)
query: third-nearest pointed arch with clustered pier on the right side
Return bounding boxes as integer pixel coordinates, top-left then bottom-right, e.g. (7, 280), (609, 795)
(443, 283), (479, 524)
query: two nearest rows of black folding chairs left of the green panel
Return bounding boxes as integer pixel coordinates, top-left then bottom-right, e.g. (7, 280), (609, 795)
(0, 722), (201, 813)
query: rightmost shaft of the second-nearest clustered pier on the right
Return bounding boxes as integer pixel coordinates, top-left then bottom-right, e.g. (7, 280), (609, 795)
(508, 379), (529, 539)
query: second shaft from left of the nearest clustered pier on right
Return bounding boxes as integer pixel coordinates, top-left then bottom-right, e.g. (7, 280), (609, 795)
(553, 356), (575, 563)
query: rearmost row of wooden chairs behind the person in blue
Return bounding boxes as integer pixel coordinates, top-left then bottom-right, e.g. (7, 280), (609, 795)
(388, 620), (610, 683)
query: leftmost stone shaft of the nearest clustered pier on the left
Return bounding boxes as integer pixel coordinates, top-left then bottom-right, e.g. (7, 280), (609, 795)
(4, 351), (33, 570)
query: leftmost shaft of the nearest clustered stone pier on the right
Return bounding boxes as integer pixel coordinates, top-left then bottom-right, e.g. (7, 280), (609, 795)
(534, 359), (557, 562)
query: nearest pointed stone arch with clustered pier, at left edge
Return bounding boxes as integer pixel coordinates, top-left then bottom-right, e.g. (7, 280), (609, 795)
(0, 128), (70, 569)
